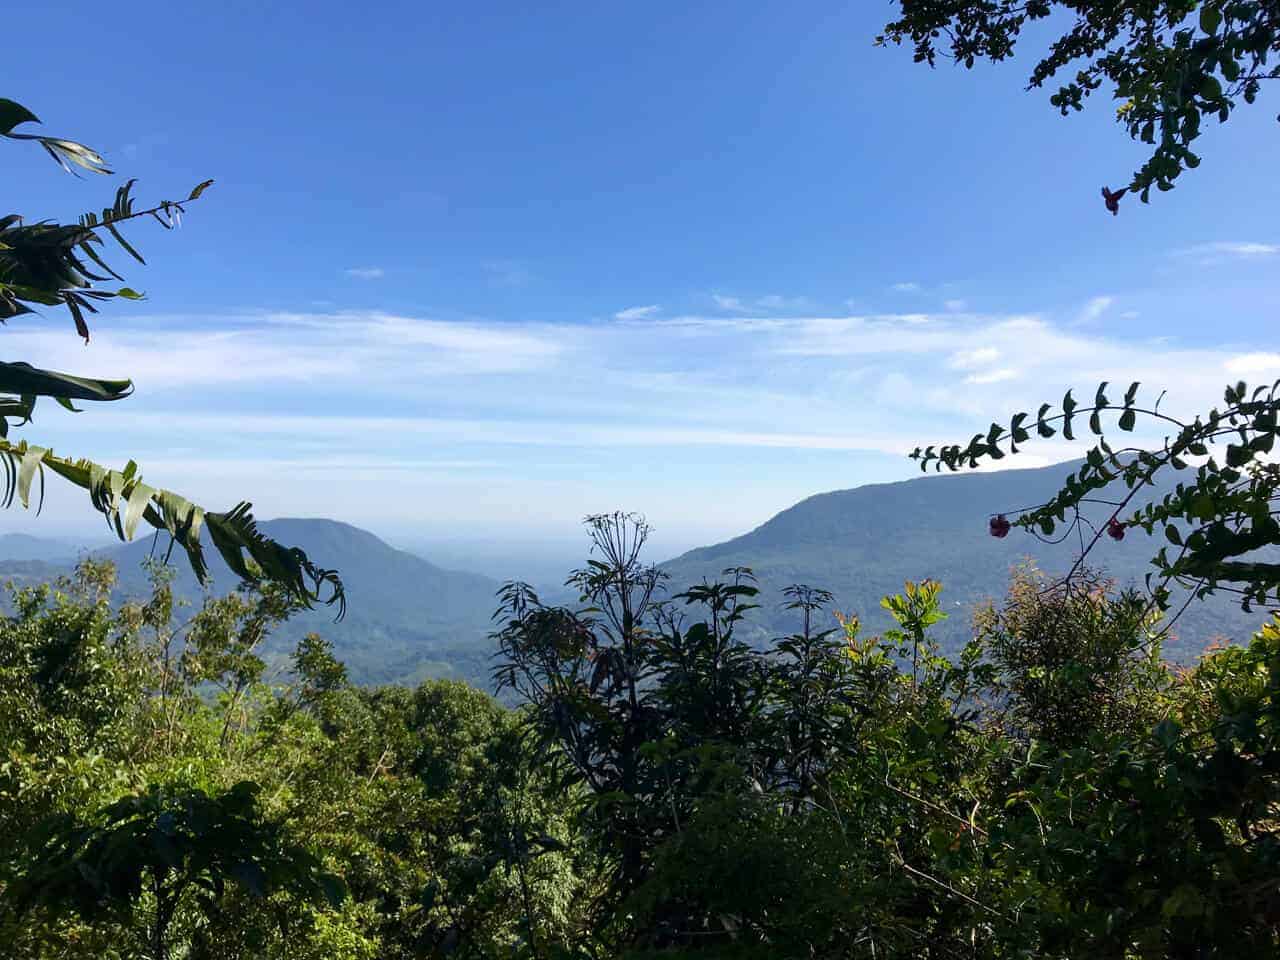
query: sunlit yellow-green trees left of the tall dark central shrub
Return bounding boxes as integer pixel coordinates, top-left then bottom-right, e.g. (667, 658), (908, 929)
(0, 563), (586, 960)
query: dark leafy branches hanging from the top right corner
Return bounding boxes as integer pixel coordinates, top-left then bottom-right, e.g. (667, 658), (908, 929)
(877, 0), (1280, 212)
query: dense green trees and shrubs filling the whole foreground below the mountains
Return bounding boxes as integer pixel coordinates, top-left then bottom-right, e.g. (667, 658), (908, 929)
(0, 516), (1280, 959)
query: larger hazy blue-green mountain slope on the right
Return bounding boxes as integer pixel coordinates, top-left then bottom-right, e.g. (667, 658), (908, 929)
(660, 463), (1262, 659)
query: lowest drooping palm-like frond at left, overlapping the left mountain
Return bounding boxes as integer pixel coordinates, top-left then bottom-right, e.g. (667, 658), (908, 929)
(0, 440), (347, 618)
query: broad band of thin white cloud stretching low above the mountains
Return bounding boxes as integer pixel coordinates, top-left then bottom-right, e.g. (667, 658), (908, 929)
(15, 304), (1280, 532)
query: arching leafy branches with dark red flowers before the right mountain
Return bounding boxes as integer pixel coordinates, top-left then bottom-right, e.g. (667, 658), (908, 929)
(911, 380), (1280, 628)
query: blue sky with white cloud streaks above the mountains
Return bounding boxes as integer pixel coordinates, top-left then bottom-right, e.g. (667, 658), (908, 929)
(3, 3), (1280, 550)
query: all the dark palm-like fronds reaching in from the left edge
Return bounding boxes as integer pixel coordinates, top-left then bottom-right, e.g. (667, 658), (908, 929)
(0, 97), (346, 617)
